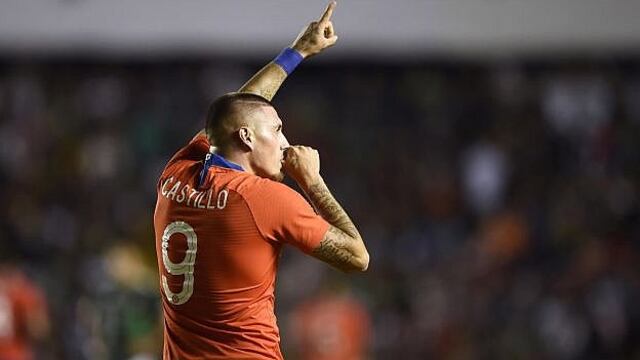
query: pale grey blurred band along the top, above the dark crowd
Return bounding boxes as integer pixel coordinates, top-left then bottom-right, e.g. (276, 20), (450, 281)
(0, 0), (640, 61)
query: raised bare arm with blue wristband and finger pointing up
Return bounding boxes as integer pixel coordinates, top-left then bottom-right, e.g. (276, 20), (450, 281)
(238, 1), (338, 101)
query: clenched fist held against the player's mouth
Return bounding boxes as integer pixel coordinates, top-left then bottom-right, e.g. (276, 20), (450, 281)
(284, 145), (322, 189)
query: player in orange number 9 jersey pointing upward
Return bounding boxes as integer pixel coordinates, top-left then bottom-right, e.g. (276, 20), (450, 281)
(154, 2), (369, 359)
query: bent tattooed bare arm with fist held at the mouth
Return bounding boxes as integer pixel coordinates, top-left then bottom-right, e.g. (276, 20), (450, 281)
(284, 146), (369, 272)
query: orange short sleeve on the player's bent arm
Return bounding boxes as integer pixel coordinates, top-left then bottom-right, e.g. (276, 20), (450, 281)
(246, 179), (329, 253)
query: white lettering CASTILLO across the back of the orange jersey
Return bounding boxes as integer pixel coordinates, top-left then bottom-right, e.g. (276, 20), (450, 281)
(160, 176), (229, 210)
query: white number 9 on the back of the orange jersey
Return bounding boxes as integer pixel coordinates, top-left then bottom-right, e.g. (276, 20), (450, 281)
(162, 221), (198, 305)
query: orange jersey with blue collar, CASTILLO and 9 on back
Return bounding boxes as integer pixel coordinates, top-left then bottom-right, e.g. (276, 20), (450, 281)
(154, 135), (329, 359)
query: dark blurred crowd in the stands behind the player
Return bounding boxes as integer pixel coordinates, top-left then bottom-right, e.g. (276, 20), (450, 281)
(0, 59), (640, 360)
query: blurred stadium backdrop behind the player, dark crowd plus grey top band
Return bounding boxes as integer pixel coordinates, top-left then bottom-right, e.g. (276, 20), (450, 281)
(0, 0), (640, 359)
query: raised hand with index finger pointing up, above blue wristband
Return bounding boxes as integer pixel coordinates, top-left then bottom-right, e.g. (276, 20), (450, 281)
(291, 1), (338, 58)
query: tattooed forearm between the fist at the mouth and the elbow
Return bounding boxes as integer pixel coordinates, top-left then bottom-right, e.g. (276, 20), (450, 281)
(305, 181), (360, 238)
